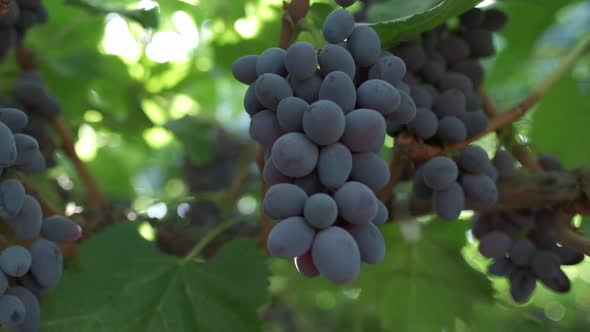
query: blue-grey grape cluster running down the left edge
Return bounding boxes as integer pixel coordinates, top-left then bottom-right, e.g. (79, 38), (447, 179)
(0, 108), (82, 331)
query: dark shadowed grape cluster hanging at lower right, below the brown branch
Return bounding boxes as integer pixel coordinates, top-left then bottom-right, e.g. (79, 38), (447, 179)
(472, 152), (584, 303)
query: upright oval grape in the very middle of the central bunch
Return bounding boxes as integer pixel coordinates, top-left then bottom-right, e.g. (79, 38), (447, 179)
(318, 143), (352, 189)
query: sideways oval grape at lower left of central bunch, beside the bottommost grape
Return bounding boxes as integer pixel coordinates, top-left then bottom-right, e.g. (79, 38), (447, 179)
(266, 217), (315, 258)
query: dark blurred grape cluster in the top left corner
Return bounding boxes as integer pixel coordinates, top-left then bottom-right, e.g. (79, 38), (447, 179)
(0, 0), (48, 61)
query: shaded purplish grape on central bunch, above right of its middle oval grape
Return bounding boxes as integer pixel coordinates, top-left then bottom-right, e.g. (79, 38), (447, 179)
(342, 108), (386, 152)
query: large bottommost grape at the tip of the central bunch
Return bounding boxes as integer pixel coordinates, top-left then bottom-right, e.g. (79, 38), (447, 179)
(311, 226), (361, 284)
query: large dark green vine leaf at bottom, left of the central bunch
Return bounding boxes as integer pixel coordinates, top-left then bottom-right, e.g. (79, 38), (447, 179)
(42, 223), (268, 332)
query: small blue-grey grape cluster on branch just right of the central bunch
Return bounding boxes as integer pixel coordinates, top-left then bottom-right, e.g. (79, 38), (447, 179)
(413, 145), (498, 220)
